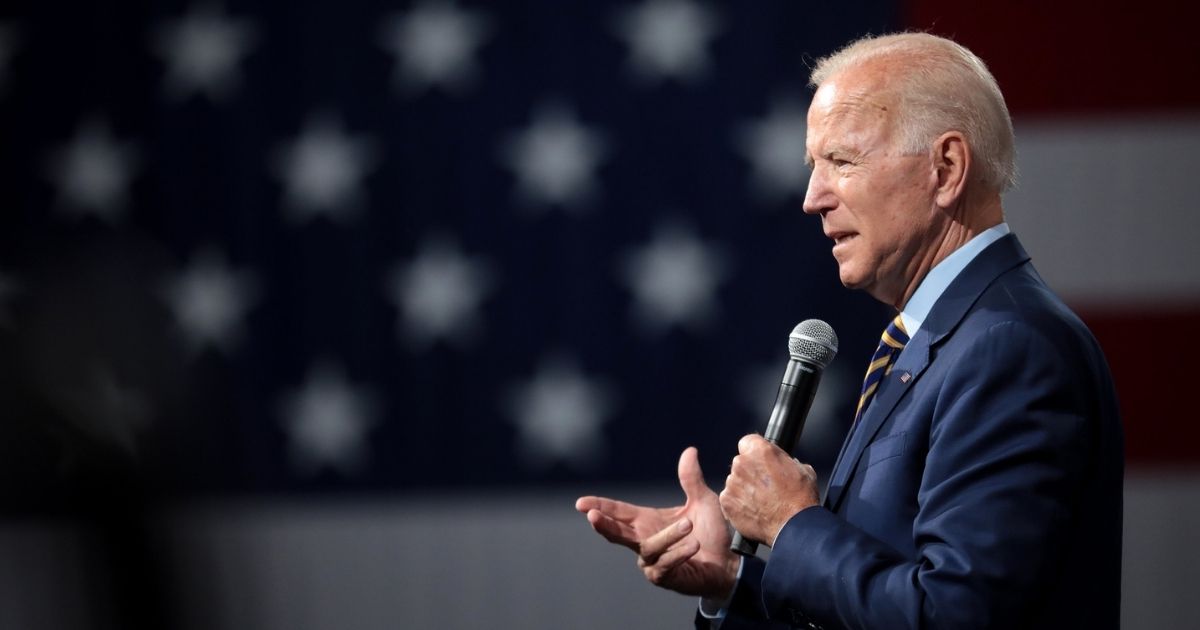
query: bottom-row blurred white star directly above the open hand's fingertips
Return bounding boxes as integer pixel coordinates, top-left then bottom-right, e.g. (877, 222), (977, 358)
(509, 359), (613, 469)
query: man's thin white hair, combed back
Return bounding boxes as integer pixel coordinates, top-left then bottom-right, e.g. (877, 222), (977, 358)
(810, 32), (1016, 192)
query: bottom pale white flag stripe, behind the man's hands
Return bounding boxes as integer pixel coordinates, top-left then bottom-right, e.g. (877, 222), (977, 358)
(0, 469), (1200, 630)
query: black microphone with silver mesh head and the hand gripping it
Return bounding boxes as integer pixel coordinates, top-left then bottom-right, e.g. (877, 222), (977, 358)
(720, 319), (838, 556)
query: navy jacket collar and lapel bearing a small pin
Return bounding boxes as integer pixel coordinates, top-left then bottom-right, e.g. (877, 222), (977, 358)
(824, 235), (1030, 511)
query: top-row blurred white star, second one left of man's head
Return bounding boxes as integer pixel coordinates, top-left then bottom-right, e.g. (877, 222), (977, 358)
(382, 1), (490, 92)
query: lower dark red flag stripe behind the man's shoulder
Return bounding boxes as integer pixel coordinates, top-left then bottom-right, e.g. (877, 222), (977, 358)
(1081, 306), (1200, 466)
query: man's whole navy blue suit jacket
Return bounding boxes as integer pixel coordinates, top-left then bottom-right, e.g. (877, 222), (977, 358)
(697, 235), (1123, 630)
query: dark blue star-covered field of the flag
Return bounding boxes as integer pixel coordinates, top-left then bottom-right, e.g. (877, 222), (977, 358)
(0, 0), (893, 504)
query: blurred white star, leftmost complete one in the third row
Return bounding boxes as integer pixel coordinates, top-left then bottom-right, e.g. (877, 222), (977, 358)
(163, 251), (256, 353)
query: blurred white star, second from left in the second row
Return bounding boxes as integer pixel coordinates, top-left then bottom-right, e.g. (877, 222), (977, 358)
(275, 116), (376, 222)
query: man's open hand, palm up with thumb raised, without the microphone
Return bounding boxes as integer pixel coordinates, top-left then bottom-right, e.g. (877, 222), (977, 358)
(575, 448), (739, 599)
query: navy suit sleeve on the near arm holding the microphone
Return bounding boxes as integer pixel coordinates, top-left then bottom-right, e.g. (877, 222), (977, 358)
(762, 323), (1094, 629)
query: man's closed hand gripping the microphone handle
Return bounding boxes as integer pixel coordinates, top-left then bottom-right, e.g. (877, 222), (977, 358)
(720, 433), (821, 545)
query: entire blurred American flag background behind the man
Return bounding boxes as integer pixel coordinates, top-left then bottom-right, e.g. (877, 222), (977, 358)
(0, 0), (1200, 630)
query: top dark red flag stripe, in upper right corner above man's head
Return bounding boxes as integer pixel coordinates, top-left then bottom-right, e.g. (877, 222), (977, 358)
(905, 0), (1200, 116)
